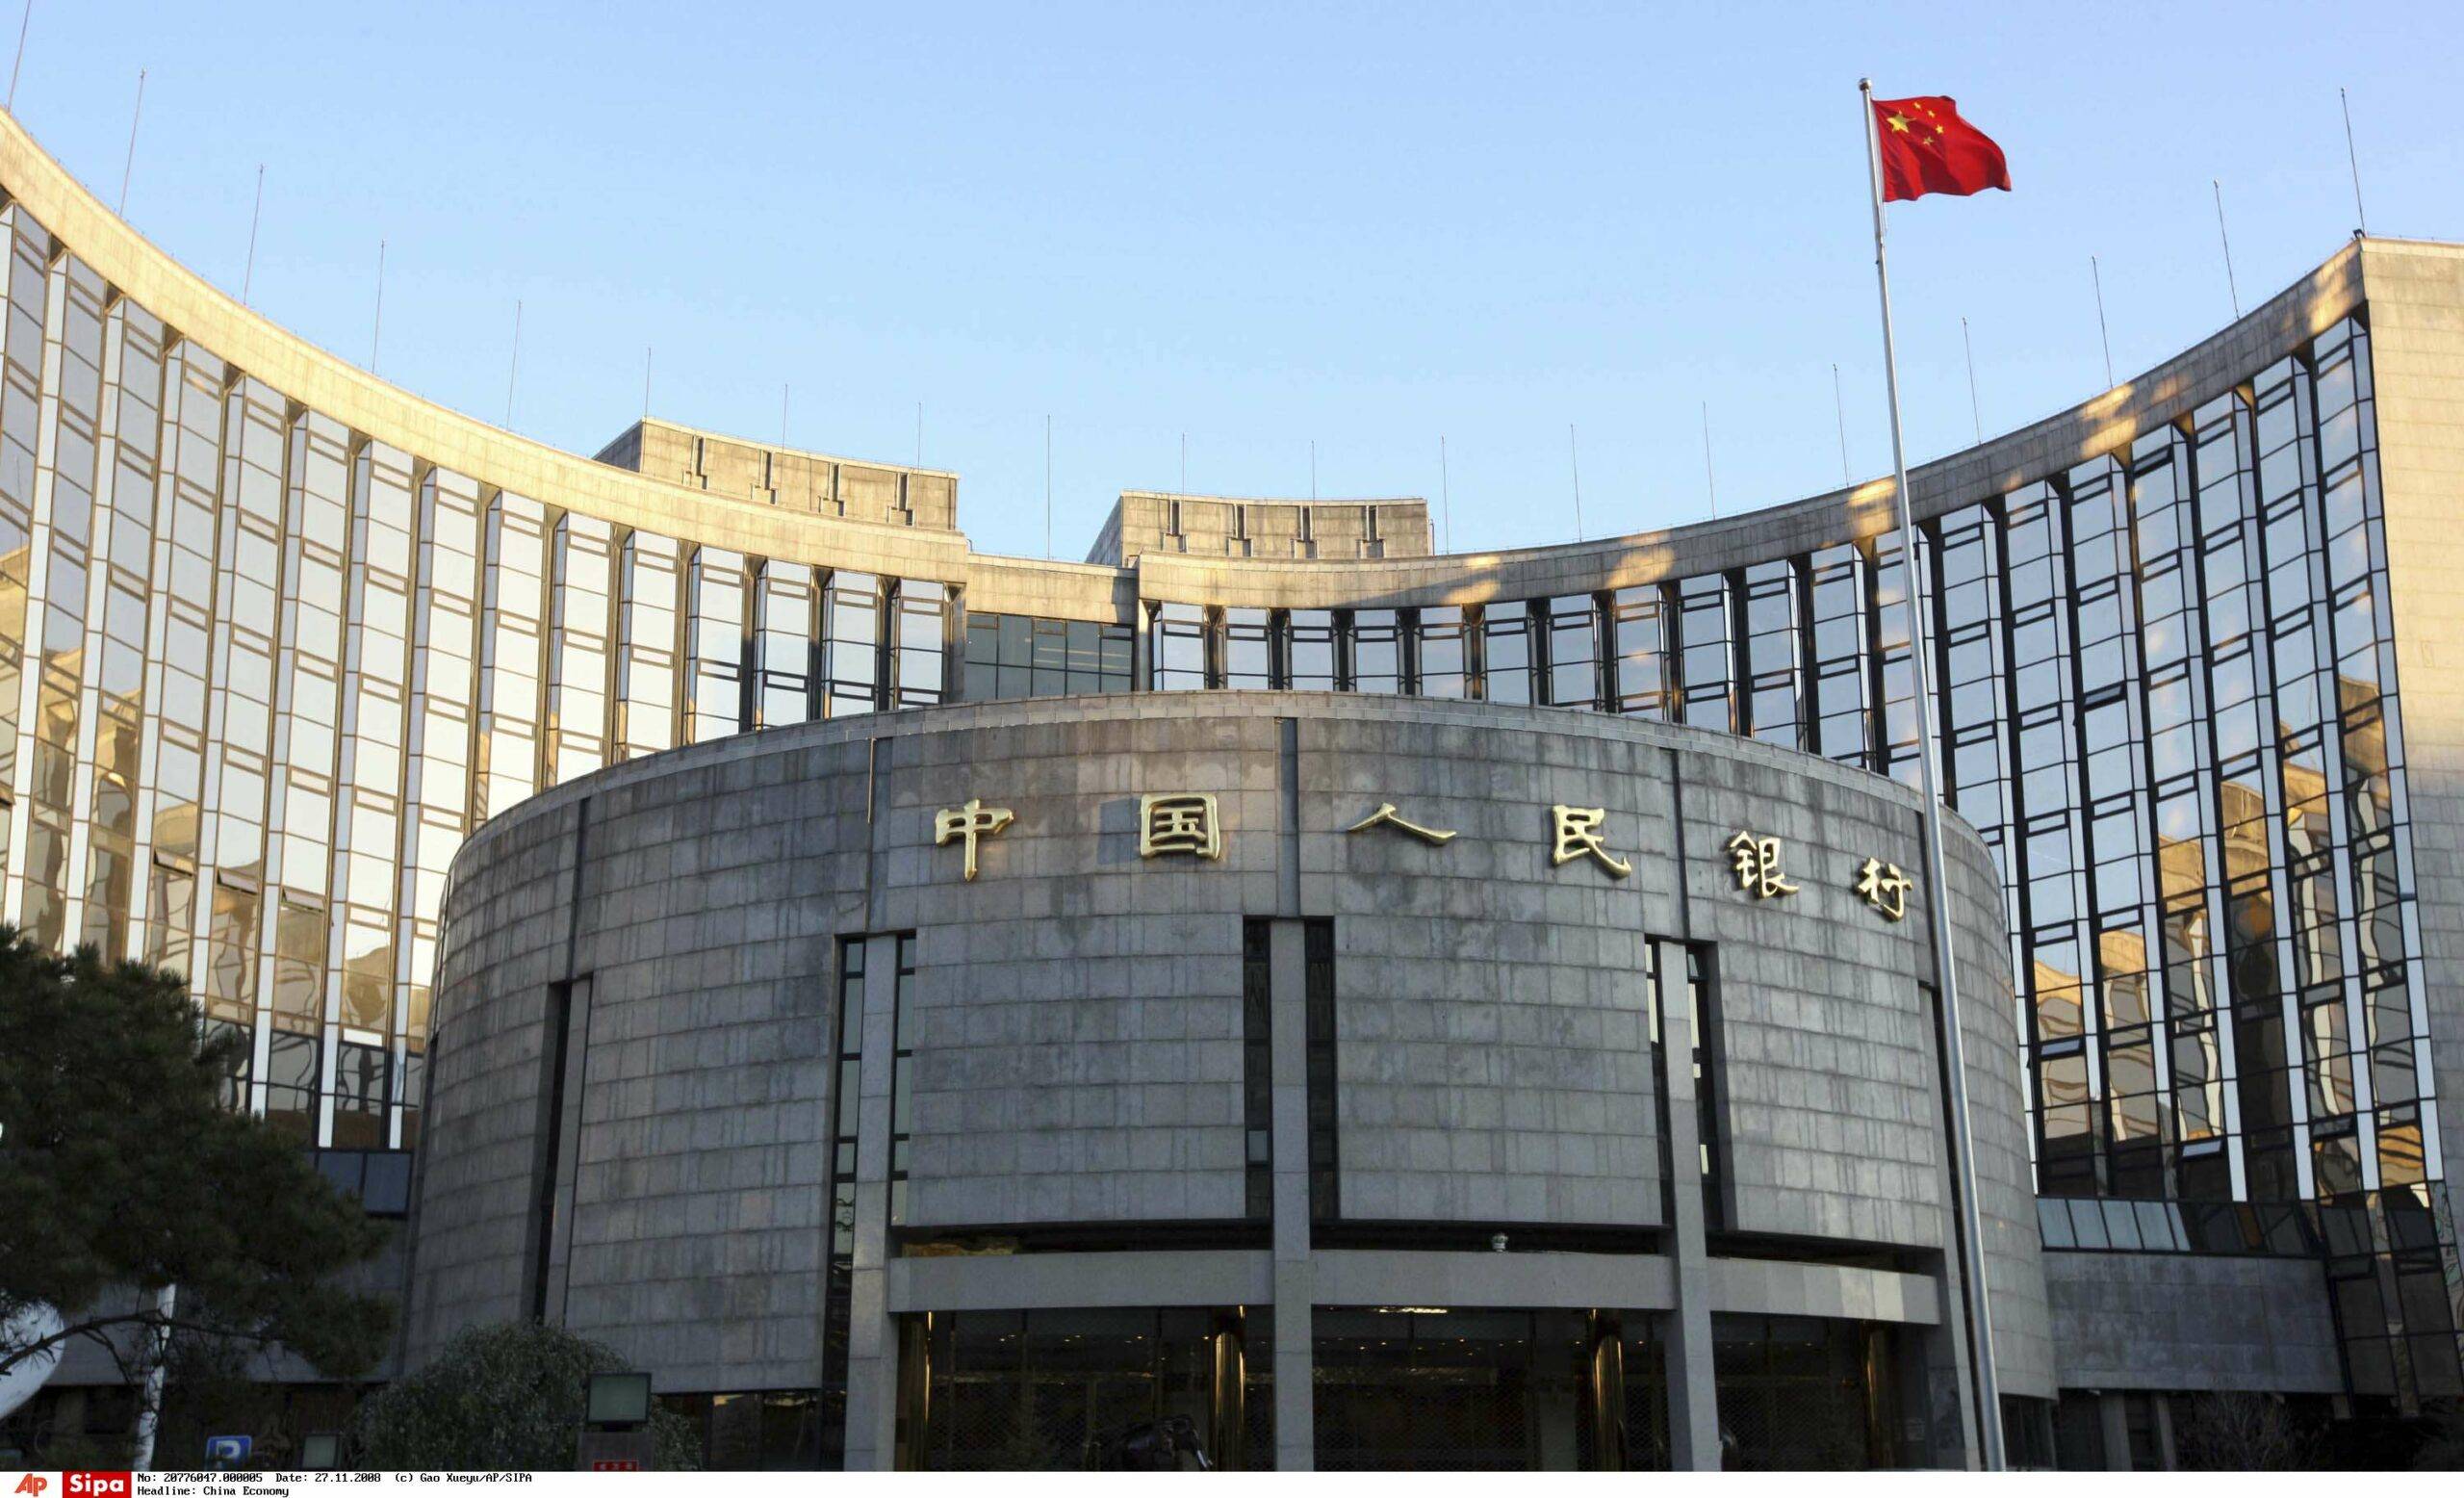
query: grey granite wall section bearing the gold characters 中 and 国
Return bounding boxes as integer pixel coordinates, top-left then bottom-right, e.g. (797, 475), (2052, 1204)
(877, 717), (1279, 1227)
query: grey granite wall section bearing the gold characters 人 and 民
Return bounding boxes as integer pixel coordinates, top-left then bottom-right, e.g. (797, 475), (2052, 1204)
(1298, 717), (1676, 1227)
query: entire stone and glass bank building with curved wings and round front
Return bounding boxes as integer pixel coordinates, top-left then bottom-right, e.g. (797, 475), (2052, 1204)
(0, 102), (2464, 1468)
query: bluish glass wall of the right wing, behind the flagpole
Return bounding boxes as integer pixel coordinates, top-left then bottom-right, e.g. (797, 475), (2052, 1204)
(1128, 318), (2464, 1397)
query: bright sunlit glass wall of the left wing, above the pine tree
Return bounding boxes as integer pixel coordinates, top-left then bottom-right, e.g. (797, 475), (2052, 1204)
(0, 204), (961, 1173)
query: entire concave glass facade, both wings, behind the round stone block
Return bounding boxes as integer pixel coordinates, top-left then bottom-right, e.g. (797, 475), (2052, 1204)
(0, 102), (2464, 1397)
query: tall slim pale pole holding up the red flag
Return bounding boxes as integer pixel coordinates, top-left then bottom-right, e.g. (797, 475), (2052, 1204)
(1858, 79), (2003, 1471)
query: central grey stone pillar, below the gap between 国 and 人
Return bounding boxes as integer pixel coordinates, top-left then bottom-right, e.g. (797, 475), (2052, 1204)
(1267, 921), (1319, 1471)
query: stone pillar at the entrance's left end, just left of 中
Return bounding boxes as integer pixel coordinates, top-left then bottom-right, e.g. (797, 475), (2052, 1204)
(848, 937), (899, 1471)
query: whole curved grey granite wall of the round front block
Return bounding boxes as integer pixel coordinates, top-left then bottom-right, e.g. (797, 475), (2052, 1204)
(414, 695), (2042, 1392)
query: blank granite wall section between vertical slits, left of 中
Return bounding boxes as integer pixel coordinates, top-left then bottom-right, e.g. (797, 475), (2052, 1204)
(562, 744), (867, 1389)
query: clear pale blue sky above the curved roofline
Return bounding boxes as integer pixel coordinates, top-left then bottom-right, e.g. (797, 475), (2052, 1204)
(0, 0), (2464, 556)
